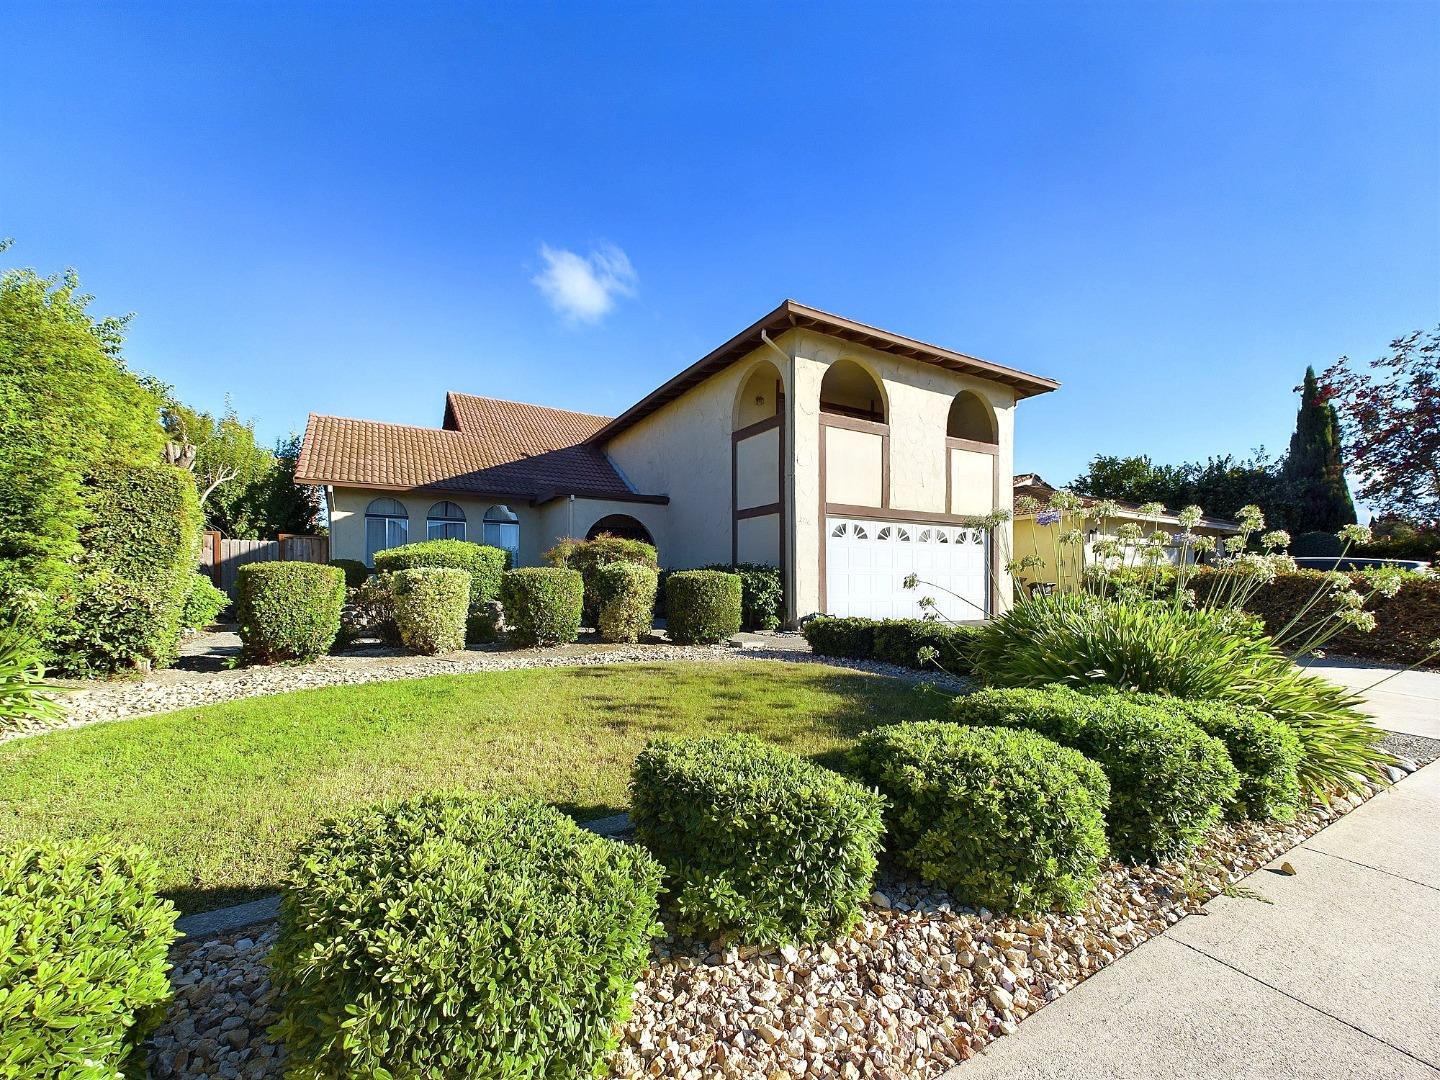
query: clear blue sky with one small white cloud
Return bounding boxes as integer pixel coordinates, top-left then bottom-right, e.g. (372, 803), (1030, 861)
(0, 3), (1440, 492)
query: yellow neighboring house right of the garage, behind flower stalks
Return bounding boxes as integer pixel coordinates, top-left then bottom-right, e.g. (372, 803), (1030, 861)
(1012, 472), (1240, 585)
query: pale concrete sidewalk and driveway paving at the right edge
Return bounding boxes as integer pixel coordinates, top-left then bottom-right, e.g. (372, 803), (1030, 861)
(945, 668), (1440, 1080)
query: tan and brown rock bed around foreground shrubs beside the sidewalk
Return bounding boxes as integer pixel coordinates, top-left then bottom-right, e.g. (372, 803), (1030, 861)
(151, 783), (1408, 1080)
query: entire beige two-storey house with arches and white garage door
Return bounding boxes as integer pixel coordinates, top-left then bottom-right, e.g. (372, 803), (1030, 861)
(295, 301), (1057, 624)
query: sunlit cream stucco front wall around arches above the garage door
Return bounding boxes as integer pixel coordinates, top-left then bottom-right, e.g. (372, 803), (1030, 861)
(778, 330), (1015, 618)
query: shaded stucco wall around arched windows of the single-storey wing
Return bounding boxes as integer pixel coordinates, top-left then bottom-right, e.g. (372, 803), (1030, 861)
(330, 488), (668, 576)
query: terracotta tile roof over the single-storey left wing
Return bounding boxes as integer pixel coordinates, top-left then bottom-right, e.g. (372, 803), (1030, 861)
(295, 393), (635, 501)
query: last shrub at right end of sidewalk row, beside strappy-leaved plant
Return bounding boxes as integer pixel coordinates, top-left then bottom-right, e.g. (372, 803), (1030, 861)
(1084, 687), (1302, 821)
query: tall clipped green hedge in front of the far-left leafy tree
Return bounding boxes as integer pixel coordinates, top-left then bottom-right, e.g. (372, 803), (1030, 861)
(49, 464), (202, 674)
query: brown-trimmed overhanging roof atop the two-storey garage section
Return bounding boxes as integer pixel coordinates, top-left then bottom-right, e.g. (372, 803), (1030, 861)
(595, 300), (1060, 442)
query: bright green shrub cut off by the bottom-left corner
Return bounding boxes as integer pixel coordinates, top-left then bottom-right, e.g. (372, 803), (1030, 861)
(0, 840), (179, 1079)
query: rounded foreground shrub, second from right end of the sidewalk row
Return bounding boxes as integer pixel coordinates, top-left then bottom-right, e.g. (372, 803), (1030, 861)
(953, 687), (1240, 861)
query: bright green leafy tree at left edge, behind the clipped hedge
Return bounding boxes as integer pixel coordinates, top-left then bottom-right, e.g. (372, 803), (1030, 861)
(0, 245), (164, 589)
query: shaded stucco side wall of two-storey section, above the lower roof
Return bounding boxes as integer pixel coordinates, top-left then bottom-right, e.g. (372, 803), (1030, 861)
(605, 348), (789, 566)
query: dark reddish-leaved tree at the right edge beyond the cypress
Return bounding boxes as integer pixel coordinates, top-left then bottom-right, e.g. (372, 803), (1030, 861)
(1319, 327), (1440, 530)
